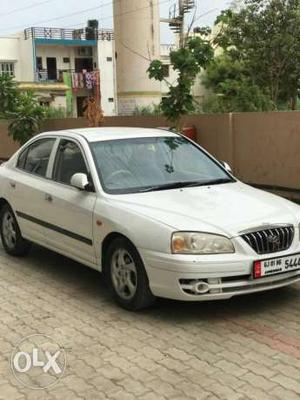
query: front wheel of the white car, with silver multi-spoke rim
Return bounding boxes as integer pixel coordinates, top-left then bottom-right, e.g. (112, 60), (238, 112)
(104, 237), (155, 311)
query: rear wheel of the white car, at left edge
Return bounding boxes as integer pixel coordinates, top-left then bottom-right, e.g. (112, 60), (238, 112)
(0, 204), (31, 257)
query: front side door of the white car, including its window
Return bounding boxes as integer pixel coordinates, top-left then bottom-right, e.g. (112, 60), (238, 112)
(44, 138), (96, 264)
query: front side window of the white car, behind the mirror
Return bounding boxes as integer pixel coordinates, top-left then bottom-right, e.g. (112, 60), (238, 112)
(53, 140), (88, 185)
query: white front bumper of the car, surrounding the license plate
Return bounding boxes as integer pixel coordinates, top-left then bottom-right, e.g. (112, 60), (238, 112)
(140, 246), (300, 301)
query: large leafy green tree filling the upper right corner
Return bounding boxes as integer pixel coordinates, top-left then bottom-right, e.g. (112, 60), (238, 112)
(215, 0), (300, 109)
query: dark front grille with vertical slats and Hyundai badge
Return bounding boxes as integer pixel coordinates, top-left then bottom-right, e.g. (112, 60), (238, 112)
(242, 226), (295, 254)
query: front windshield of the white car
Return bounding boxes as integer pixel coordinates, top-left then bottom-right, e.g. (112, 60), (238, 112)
(90, 136), (235, 194)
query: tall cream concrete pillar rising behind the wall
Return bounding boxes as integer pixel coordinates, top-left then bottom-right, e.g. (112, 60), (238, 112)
(114, 0), (161, 115)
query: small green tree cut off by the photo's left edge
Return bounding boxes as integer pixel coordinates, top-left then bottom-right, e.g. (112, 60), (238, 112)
(0, 74), (18, 118)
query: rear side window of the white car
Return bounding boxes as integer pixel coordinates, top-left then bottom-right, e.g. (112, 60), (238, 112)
(17, 139), (55, 177)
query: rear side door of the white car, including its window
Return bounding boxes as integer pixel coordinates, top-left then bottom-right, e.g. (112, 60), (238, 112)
(7, 137), (56, 244)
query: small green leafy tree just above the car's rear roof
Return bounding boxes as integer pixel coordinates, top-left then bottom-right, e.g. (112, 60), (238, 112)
(7, 92), (45, 145)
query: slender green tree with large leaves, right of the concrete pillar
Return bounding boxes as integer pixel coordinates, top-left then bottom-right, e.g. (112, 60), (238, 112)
(148, 32), (213, 129)
